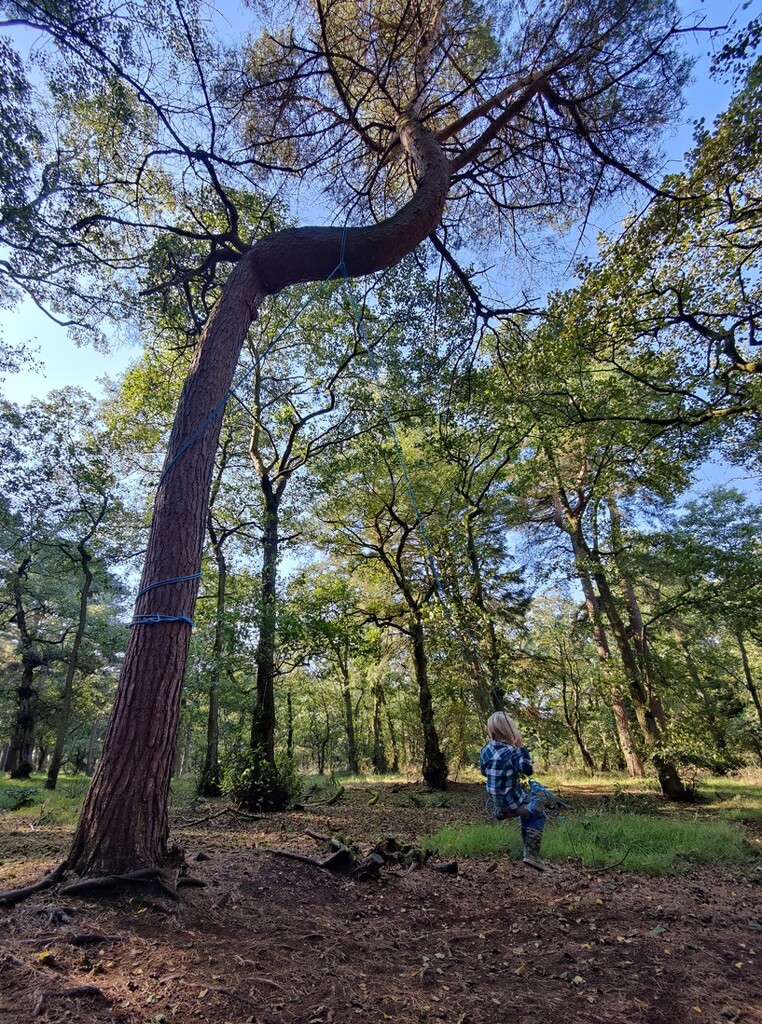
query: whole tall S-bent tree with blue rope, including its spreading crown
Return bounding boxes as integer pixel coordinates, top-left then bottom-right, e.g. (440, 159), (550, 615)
(0, 0), (687, 873)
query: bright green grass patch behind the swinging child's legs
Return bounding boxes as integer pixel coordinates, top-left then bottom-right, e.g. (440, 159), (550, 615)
(421, 813), (757, 876)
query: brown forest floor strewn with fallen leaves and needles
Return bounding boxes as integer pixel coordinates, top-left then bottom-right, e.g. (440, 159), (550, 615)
(0, 782), (762, 1024)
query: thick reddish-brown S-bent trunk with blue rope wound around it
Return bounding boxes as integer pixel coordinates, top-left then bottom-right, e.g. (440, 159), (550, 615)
(69, 118), (451, 874)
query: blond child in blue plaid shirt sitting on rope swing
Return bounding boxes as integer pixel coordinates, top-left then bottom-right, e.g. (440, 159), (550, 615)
(479, 711), (546, 871)
